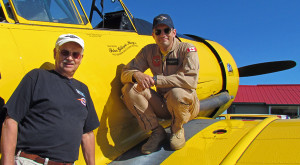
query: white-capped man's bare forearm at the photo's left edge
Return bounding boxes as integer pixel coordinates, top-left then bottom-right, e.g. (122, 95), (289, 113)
(1, 116), (18, 165)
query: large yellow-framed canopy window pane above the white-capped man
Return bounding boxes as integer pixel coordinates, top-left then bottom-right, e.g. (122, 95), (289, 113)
(13, 0), (87, 24)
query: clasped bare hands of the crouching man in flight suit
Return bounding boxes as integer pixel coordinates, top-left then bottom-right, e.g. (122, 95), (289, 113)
(133, 72), (155, 91)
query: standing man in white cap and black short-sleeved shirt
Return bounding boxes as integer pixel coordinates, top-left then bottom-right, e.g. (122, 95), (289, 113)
(1, 34), (99, 165)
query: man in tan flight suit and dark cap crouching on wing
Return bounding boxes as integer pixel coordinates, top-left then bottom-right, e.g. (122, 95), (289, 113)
(121, 14), (200, 154)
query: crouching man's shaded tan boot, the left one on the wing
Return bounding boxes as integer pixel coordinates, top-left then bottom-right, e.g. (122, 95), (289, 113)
(141, 126), (167, 155)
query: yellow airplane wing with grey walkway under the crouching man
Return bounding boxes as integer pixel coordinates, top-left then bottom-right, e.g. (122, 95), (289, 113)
(110, 118), (300, 165)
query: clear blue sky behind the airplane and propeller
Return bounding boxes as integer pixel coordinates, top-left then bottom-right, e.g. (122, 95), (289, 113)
(82, 0), (300, 85)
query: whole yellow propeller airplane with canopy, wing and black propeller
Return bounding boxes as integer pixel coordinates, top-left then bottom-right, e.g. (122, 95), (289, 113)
(0, 0), (300, 164)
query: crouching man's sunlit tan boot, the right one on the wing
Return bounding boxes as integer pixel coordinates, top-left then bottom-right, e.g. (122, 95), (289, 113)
(170, 128), (185, 150)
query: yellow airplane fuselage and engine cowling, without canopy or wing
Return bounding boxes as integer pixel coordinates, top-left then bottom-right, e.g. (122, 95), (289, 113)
(0, 1), (239, 164)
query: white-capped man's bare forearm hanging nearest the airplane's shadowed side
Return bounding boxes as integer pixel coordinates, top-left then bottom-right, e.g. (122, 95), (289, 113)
(81, 131), (95, 165)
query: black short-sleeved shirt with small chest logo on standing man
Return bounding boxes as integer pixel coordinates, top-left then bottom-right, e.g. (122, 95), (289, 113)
(4, 69), (99, 162)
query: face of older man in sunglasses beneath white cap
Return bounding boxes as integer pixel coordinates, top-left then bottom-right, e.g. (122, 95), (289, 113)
(54, 42), (83, 78)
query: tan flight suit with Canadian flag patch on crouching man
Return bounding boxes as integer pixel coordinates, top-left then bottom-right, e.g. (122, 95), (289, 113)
(121, 38), (200, 132)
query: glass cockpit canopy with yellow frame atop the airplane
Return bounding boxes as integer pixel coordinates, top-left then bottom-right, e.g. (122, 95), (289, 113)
(0, 0), (152, 35)
